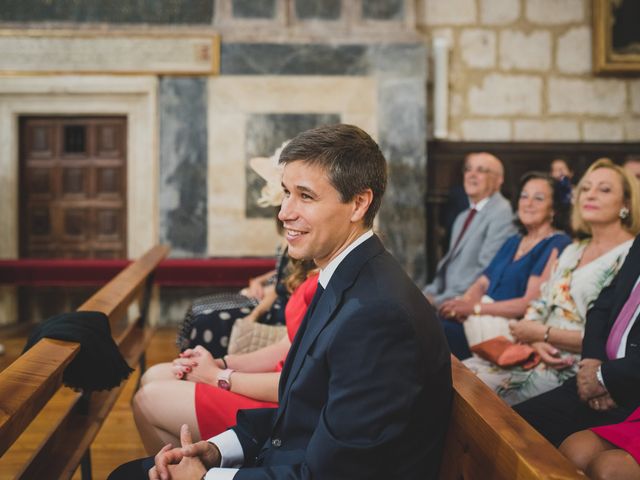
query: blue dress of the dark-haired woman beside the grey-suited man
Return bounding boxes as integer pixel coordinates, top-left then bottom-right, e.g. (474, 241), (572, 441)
(441, 233), (571, 360)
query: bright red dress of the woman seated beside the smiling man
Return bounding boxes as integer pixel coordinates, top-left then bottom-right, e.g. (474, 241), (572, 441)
(195, 274), (318, 439)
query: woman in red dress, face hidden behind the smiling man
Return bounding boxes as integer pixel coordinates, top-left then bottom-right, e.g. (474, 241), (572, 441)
(133, 260), (318, 454)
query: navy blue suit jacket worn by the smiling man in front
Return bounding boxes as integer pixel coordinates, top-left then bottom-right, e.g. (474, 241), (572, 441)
(234, 236), (452, 480)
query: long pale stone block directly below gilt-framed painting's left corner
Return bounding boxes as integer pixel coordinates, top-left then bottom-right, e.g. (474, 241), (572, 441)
(547, 78), (627, 116)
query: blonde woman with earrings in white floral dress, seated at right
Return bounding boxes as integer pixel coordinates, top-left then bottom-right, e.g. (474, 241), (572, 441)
(464, 159), (640, 405)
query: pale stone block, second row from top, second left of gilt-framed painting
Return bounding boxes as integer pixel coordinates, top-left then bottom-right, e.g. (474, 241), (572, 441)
(500, 30), (551, 71)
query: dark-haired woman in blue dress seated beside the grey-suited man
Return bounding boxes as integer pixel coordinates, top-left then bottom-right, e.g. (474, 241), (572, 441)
(439, 172), (571, 360)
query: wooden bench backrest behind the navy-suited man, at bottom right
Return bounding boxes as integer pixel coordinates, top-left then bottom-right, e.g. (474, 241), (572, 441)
(440, 356), (586, 480)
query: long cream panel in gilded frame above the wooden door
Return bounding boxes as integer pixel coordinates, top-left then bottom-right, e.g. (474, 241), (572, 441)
(0, 29), (220, 76)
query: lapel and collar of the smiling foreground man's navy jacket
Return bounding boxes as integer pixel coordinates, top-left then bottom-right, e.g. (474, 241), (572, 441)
(274, 235), (384, 425)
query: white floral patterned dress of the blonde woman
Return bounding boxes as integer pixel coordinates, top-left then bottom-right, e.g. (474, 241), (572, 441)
(464, 239), (633, 405)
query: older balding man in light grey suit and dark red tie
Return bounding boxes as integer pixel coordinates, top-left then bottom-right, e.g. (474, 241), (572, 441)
(423, 153), (515, 306)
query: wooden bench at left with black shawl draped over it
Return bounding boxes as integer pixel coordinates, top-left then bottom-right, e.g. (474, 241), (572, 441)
(0, 246), (169, 478)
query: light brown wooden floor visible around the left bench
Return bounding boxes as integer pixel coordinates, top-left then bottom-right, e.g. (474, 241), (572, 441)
(0, 329), (177, 480)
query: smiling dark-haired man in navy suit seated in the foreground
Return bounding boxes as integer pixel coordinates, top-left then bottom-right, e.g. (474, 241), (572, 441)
(111, 125), (452, 480)
